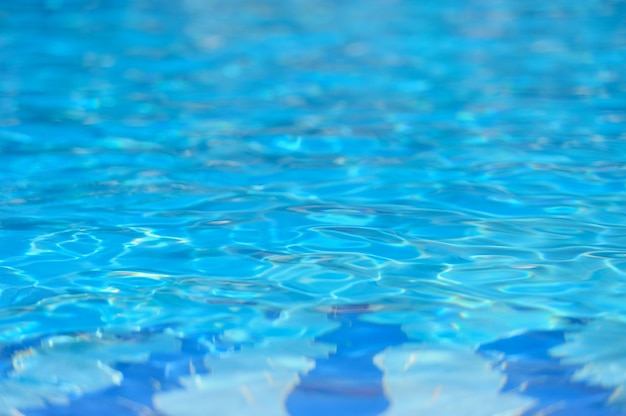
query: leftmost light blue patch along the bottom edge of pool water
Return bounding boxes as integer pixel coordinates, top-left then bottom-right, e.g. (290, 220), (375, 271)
(0, 334), (180, 416)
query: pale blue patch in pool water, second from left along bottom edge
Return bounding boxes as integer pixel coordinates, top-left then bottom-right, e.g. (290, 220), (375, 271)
(154, 340), (332, 416)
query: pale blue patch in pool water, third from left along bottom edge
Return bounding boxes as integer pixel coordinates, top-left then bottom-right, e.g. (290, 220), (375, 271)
(374, 344), (533, 416)
